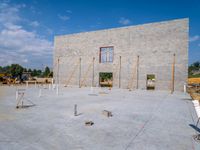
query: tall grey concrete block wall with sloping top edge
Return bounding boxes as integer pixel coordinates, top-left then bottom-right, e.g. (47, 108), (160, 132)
(54, 18), (189, 91)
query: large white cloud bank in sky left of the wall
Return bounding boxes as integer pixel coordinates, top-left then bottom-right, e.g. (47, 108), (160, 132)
(0, 3), (53, 66)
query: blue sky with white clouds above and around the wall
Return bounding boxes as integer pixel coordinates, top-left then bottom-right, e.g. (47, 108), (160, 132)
(0, 0), (200, 69)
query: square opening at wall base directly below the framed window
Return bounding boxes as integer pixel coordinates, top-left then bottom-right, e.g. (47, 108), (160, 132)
(99, 72), (113, 87)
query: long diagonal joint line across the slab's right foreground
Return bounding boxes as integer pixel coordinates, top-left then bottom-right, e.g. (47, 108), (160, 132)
(125, 95), (168, 150)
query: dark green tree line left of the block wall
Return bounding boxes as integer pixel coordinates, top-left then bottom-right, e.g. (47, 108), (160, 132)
(0, 64), (53, 78)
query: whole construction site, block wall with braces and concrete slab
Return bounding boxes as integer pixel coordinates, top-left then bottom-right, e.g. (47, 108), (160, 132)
(0, 18), (200, 150)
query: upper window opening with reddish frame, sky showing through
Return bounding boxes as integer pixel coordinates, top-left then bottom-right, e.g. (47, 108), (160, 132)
(99, 46), (113, 63)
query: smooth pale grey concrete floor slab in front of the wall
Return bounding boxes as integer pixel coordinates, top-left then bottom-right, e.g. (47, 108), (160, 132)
(0, 86), (200, 150)
